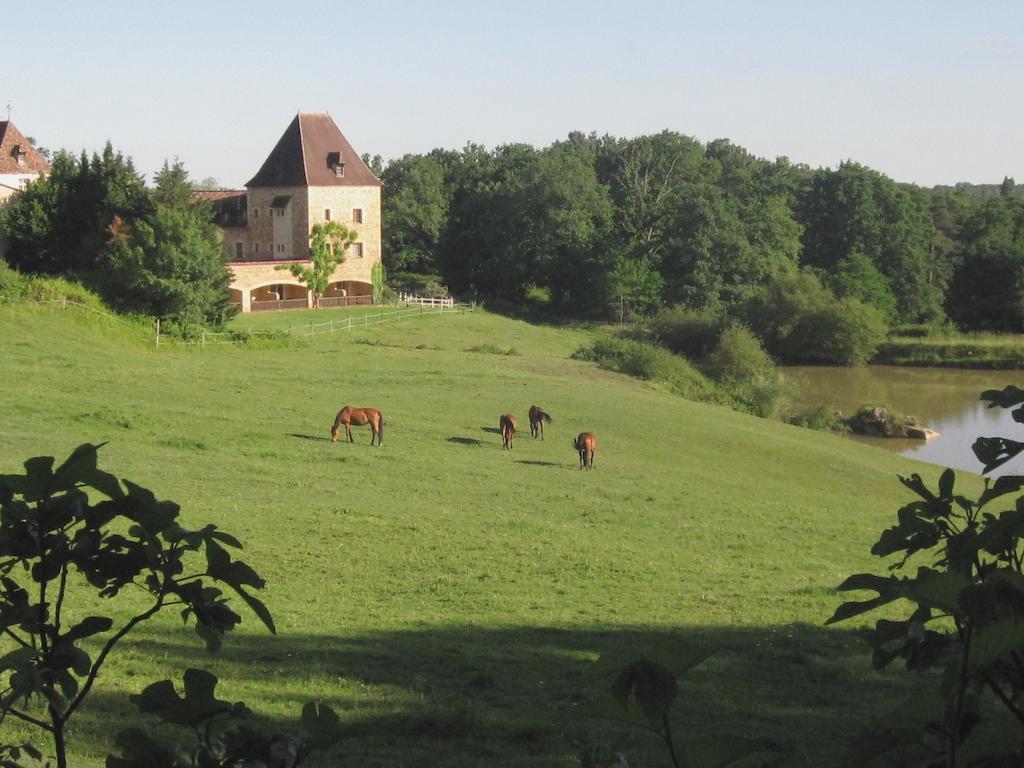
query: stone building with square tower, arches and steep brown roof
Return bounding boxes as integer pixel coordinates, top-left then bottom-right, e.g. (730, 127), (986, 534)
(204, 113), (381, 312)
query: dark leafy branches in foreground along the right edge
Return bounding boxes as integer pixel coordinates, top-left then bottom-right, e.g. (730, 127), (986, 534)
(826, 386), (1024, 768)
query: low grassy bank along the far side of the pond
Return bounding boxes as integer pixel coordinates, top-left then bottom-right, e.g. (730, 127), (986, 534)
(871, 334), (1024, 371)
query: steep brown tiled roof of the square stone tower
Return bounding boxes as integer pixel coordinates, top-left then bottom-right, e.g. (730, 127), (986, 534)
(246, 113), (381, 186)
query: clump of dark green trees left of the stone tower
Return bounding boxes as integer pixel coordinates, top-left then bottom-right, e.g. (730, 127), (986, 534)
(0, 142), (232, 329)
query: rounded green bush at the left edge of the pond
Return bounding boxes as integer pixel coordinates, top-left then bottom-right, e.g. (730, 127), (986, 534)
(708, 326), (782, 416)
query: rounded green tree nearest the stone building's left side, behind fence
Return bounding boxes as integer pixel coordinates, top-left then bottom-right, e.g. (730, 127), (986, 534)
(102, 160), (231, 326)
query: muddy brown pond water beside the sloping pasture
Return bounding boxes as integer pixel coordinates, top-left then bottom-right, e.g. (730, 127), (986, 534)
(782, 366), (1024, 476)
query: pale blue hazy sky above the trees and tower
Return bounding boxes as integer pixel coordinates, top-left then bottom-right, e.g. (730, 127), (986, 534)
(0, 0), (1024, 186)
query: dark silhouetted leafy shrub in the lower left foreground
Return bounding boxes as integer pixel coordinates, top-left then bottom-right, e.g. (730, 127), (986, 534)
(0, 444), (275, 768)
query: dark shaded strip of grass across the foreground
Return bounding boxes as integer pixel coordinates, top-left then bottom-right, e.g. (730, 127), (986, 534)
(58, 625), (932, 768)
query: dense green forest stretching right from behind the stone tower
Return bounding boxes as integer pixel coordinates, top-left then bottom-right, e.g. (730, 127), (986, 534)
(380, 131), (1024, 331)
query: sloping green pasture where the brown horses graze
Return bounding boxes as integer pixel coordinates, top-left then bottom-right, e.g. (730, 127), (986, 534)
(0, 305), (974, 767)
